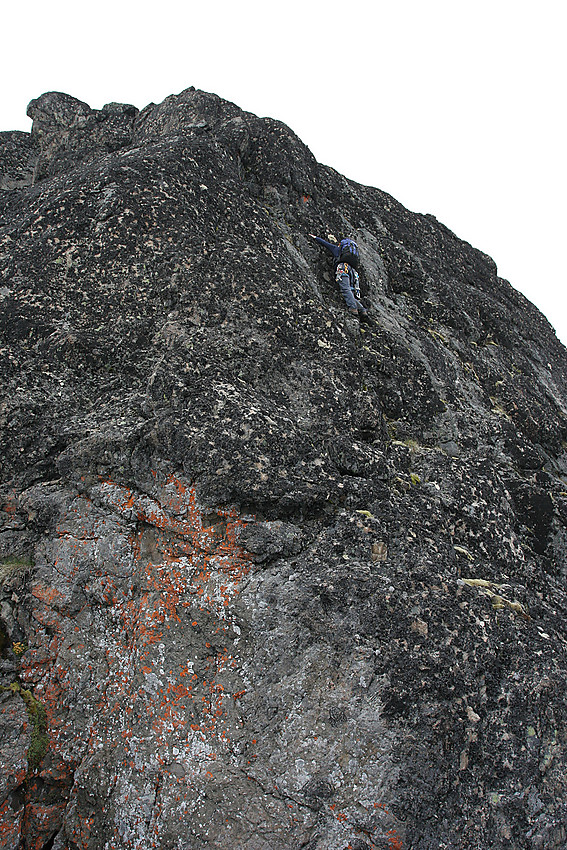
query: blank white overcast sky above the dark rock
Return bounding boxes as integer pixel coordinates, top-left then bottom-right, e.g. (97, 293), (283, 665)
(0, 0), (567, 344)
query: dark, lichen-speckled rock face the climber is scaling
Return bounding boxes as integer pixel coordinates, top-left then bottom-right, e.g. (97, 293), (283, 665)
(0, 89), (567, 850)
